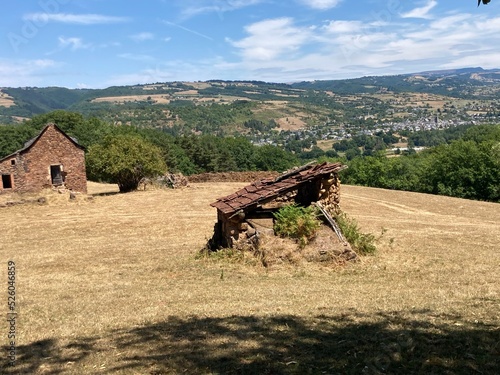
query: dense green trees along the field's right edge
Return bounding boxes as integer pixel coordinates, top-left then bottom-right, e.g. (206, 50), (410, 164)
(343, 125), (500, 202)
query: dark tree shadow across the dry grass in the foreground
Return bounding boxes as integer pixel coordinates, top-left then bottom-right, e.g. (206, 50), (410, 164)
(2, 312), (500, 374)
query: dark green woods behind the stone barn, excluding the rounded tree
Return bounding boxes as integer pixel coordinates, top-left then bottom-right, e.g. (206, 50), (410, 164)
(0, 111), (300, 179)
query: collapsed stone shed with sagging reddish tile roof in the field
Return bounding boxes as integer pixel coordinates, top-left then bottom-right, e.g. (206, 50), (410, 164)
(208, 162), (346, 250)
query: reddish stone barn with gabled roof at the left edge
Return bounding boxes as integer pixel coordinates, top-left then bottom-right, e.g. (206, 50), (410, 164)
(0, 124), (87, 193)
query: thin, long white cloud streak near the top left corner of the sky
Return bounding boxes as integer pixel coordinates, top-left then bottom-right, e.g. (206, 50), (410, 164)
(23, 13), (129, 25)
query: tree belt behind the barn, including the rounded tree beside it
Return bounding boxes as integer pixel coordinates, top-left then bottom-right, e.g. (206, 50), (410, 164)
(0, 110), (300, 191)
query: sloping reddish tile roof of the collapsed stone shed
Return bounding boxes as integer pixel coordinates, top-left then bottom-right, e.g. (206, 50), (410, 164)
(210, 162), (346, 215)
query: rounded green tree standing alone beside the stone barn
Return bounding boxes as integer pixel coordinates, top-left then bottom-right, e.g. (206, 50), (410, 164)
(86, 134), (167, 192)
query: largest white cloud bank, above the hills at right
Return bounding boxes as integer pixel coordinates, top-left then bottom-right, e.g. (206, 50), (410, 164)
(223, 10), (500, 82)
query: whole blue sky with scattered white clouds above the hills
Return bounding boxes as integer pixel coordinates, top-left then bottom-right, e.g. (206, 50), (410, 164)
(0, 0), (500, 88)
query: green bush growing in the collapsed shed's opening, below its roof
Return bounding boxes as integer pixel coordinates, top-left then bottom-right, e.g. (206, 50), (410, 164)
(274, 205), (321, 248)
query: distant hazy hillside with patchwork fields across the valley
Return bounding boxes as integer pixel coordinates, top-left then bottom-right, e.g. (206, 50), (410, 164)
(0, 68), (500, 135)
